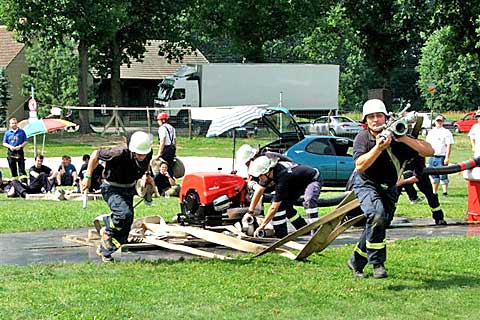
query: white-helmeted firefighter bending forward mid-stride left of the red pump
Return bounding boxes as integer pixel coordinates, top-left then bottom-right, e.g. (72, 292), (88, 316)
(82, 131), (154, 261)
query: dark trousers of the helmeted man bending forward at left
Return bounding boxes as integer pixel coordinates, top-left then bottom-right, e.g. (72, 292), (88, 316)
(100, 184), (135, 256)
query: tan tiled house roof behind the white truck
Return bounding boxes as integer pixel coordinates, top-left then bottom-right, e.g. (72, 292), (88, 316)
(120, 40), (208, 79)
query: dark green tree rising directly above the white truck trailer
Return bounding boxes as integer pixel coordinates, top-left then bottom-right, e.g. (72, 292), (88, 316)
(186, 0), (326, 62)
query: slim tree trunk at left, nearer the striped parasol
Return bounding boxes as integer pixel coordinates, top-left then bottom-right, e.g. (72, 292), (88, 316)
(78, 39), (92, 133)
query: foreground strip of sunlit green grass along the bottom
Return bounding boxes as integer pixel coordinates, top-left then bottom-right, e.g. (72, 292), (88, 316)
(0, 237), (480, 319)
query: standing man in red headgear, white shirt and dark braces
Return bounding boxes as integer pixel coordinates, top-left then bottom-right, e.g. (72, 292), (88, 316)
(157, 112), (177, 177)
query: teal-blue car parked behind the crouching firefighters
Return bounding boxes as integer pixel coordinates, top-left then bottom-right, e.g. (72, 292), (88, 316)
(284, 136), (355, 187)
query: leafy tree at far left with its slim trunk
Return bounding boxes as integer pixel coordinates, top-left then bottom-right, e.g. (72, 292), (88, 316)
(0, 0), (120, 133)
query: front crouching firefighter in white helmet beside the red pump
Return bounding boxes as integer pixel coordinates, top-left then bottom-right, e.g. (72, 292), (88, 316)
(248, 156), (322, 238)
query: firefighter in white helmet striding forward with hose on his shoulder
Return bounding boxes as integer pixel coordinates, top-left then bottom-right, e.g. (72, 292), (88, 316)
(348, 99), (433, 278)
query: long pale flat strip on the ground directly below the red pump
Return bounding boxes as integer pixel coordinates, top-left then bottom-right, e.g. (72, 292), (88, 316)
(144, 223), (295, 260)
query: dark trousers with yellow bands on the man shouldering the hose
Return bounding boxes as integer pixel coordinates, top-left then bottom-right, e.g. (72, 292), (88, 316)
(351, 175), (398, 269)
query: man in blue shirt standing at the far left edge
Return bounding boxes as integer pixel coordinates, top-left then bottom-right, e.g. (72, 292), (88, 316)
(3, 118), (27, 183)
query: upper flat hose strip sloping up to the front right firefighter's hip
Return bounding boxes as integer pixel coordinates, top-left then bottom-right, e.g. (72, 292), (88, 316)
(253, 194), (359, 256)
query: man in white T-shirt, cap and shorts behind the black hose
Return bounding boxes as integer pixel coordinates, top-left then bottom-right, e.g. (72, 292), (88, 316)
(425, 115), (454, 197)
